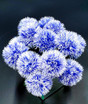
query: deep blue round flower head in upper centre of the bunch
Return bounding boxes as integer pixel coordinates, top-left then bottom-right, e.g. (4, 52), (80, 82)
(34, 29), (57, 52)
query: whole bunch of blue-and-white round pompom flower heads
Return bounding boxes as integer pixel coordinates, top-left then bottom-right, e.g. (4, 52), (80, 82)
(2, 17), (86, 97)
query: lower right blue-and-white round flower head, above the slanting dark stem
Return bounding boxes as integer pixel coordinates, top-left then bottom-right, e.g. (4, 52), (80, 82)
(59, 59), (83, 86)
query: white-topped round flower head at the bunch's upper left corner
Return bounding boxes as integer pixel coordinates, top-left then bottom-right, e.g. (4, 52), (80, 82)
(18, 17), (39, 40)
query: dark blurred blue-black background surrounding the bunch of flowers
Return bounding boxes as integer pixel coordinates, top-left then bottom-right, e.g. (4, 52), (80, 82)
(0, 0), (88, 104)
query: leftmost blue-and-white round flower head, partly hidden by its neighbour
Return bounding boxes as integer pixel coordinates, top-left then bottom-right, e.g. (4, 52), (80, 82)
(2, 38), (29, 69)
